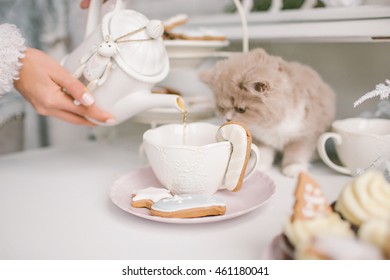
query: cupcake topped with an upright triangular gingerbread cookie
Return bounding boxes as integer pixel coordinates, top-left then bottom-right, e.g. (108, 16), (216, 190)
(280, 173), (354, 258)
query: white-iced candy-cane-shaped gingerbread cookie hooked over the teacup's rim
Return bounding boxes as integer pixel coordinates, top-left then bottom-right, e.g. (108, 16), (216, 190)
(217, 122), (252, 192)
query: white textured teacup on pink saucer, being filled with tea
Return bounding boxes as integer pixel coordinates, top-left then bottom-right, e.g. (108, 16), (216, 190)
(143, 122), (259, 194)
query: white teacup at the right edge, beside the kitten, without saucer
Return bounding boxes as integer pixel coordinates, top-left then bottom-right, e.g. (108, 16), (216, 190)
(317, 118), (390, 175)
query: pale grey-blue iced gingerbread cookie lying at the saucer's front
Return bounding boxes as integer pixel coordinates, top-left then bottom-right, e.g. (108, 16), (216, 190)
(150, 194), (226, 218)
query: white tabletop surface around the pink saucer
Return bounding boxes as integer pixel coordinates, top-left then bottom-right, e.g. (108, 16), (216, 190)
(0, 136), (350, 260)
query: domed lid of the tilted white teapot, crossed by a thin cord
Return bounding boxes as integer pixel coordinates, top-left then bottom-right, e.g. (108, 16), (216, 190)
(102, 10), (169, 83)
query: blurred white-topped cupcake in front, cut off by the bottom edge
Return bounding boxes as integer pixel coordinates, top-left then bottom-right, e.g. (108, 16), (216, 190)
(295, 235), (383, 260)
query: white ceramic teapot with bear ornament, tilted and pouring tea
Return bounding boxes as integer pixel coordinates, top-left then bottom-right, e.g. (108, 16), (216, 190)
(63, 0), (185, 125)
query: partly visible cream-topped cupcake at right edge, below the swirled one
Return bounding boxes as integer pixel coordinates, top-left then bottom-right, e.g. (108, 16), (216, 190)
(357, 220), (390, 259)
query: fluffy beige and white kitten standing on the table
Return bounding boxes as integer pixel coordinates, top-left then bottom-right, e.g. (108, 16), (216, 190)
(199, 48), (336, 177)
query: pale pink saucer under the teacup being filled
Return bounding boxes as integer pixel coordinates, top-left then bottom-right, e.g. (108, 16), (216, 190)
(110, 166), (275, 224)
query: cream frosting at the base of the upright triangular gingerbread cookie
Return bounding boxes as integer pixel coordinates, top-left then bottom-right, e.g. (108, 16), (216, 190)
(284, 213), (353, 246)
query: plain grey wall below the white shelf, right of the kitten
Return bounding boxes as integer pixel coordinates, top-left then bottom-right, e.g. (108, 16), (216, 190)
(248, 43), (390, 118)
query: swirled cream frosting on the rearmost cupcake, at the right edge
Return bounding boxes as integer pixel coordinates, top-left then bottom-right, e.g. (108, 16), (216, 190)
(335, 171), (390, 226)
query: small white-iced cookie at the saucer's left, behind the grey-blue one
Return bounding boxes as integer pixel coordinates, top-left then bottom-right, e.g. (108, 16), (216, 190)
(131, 187), (172, 209)
